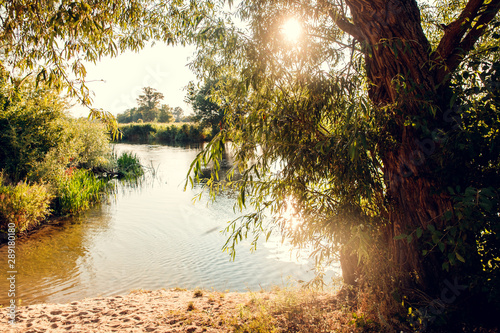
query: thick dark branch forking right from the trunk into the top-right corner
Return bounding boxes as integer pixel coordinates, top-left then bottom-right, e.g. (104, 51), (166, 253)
(433, 0), (500, 82)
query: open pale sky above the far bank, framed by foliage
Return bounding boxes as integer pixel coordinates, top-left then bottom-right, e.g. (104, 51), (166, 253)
(70, 44), (196, 117)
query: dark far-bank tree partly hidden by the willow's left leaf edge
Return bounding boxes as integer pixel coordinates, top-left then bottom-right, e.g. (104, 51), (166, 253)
(186, 80), (224, 135)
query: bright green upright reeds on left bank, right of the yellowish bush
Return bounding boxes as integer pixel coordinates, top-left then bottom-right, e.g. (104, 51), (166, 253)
(54, 168), (109, 215)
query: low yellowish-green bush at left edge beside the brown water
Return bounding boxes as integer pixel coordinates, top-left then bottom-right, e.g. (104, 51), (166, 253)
(0, 173), (53, 233)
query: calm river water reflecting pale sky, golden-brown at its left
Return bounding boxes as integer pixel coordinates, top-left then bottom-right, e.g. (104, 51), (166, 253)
(0, 144), (340, 305)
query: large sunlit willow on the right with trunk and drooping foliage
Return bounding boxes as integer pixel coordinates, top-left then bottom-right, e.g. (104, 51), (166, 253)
(188, 0), (500, 326)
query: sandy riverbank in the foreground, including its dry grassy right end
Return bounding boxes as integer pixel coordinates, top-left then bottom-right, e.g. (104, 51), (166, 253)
(0, 288), (360, 333)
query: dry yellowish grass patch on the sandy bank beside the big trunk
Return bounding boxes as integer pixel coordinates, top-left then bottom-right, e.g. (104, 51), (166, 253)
(160, 287), (376, 333)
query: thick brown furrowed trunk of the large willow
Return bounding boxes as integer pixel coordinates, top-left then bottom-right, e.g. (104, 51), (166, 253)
(346, 0), (452, 293)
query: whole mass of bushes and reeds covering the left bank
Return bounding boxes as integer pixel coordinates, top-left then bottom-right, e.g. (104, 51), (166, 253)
(0, 72), (143, 240)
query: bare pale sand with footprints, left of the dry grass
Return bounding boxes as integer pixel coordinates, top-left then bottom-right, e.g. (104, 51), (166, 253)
(0, 289), (254, 333)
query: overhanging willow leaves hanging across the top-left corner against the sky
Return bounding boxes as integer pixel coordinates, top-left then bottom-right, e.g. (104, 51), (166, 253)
(0, 0), (212, 131)
